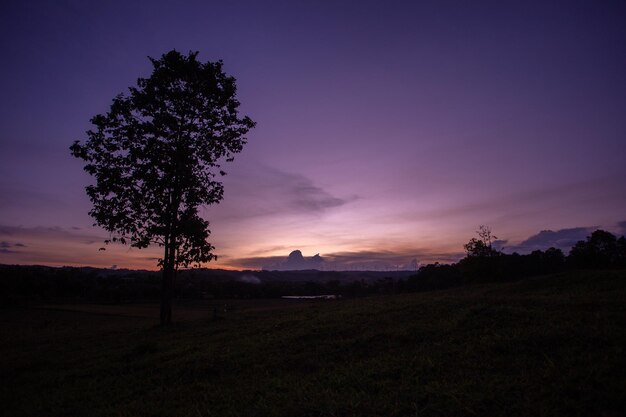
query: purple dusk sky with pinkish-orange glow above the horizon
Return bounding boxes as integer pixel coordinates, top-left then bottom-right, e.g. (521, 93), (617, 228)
(0, 0), (626, 269)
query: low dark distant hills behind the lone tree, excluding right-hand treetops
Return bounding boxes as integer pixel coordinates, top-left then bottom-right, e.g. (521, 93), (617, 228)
(0, 265), (415, 305)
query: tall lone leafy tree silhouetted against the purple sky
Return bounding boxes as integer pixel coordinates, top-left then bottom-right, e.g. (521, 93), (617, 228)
(70, 50), (255, 325)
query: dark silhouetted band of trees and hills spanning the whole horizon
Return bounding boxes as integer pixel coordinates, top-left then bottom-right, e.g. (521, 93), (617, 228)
(0, 227), (626, 305)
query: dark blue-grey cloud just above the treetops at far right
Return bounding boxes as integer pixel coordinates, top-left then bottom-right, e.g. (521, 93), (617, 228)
(504, 226), (597, 254)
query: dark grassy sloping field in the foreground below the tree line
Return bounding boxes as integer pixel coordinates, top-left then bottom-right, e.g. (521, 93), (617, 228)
(0, 271), (626, 416)
